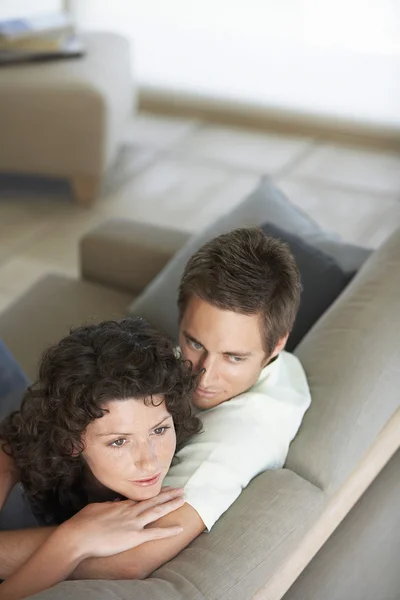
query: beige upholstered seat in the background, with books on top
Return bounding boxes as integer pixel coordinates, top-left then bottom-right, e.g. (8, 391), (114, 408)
(0, 33), (134, 205)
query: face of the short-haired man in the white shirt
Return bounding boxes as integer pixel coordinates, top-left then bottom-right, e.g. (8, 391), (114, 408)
(179, 296), (269, 410)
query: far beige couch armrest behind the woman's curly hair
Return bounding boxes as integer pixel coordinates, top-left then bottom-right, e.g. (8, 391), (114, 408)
(80, 220), (190, 296)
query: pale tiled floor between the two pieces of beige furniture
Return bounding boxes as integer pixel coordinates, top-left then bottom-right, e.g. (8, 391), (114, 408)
(0, 114), (400, 311)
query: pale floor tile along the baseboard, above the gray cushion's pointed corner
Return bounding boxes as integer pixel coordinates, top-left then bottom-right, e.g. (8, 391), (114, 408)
(175, 126), (314, 174)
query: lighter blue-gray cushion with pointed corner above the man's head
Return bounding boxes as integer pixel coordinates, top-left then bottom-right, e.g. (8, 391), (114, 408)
(129, 179), (370, 340)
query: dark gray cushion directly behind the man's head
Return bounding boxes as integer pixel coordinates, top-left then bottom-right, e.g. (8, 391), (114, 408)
(261, 223), (355, 352)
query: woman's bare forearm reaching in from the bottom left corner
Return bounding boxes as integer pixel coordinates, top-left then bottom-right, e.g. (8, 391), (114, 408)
(0, 526), (85, 600)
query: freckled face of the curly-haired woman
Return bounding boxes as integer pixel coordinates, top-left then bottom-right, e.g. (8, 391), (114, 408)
(82, 396), (176, 501)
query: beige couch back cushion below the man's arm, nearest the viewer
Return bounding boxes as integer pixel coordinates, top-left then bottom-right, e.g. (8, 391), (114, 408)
(27, 469), (329, 600)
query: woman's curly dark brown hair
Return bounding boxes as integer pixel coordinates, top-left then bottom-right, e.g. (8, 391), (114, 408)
(0, 317), (201, 523)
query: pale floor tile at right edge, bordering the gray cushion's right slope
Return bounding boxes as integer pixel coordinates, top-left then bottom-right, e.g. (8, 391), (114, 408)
(278, 179), (400, 248)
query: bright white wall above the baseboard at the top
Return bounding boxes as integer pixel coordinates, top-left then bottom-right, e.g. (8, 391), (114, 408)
(24, 0), (400, 127)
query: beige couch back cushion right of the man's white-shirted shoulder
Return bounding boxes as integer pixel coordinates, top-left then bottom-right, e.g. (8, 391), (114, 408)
(286, 230), (400, 493)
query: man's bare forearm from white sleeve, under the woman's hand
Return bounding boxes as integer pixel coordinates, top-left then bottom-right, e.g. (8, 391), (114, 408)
(70, 504), (205, 579)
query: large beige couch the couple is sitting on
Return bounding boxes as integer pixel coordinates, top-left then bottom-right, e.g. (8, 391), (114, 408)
(0, 221), (400, 600)
